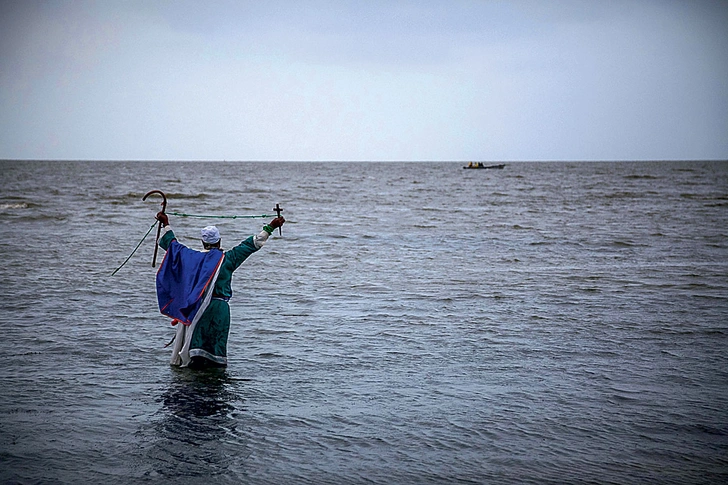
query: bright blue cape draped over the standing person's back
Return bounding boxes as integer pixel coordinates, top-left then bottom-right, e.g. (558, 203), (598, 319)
(157, 240), (225, 325)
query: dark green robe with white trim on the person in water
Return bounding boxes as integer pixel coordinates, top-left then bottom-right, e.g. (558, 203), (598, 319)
(159, 226), (268, 366)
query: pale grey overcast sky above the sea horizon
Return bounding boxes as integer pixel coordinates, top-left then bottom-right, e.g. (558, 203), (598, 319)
(0, 0), (728, 161)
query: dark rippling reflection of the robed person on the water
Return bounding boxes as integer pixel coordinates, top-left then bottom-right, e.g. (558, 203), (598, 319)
(145, 368), (249, 483)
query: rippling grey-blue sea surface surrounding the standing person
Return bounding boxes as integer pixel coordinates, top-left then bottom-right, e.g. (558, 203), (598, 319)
(0, 161), (728, 484)
